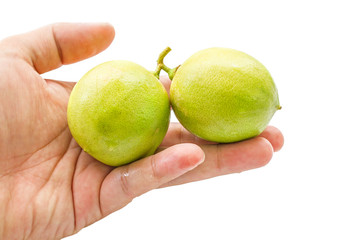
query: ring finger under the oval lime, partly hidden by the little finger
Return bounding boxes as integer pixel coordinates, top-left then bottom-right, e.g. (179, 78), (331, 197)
(161, 137), (273, 187)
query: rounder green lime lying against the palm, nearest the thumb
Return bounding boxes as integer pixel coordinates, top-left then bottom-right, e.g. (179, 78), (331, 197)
(67, 61), (170, 166)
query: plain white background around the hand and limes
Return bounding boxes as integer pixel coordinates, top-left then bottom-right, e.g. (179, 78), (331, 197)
(0, 0), (360, 240)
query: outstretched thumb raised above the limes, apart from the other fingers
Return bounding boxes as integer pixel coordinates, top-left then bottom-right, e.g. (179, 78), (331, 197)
(2, 23), (115, 74)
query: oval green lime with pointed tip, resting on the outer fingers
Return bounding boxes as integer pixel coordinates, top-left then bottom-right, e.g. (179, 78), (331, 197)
(170, 48), (281, 143)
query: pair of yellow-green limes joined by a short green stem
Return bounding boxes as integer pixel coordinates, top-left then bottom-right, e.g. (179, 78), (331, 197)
(68, 48), (280, 166)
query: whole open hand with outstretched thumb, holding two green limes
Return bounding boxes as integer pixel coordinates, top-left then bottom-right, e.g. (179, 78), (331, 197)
(0, 23), (284, 239)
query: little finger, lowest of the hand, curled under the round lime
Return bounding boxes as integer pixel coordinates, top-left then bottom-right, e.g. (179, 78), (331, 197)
(100, 144), (204, 215)
